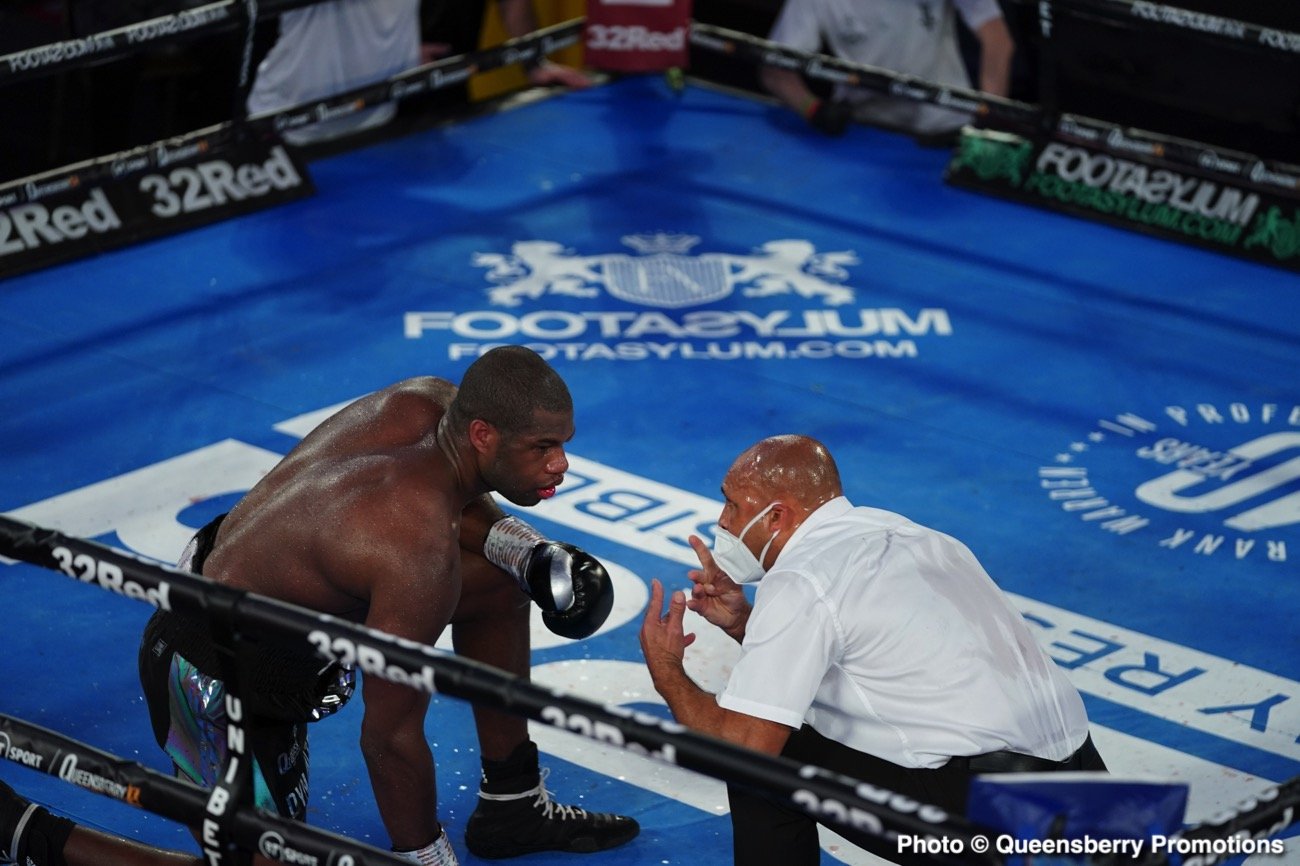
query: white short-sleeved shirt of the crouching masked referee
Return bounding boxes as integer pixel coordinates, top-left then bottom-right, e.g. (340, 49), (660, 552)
(718, 497), (1088, 767)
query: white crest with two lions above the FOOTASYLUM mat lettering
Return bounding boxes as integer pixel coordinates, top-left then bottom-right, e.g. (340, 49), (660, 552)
(473, 233), (858, 308)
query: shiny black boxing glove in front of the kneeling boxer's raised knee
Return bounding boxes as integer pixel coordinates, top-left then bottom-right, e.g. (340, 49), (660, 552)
(524, 541), (614, 641)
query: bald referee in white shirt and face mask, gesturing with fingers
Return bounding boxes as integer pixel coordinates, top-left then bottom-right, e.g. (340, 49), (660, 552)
(641, 436), (1105, 866)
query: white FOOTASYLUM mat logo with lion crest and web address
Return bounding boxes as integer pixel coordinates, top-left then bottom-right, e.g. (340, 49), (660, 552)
(404, 233), (953, 361)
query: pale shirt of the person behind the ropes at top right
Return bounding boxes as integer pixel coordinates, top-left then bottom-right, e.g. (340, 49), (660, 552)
(768, 0), (1002, 133)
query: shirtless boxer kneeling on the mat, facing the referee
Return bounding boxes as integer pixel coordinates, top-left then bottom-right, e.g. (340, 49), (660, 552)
(140, 346), (640, 865)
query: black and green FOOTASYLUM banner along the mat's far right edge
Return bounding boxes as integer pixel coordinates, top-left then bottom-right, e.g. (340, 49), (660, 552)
(945, 127), (1300, 270)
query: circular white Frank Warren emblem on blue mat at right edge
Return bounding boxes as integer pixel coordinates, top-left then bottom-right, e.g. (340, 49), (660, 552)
(1039, 402), (1300, 563)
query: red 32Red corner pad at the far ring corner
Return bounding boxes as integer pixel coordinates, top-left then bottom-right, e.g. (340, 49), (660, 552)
(584, 0), (690, 72)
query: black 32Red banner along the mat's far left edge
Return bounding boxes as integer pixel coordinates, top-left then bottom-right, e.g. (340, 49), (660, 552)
(0, 139), (315, 277)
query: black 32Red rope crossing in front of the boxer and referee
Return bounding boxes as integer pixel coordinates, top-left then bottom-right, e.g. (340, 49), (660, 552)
(0, 515), (1000, 863)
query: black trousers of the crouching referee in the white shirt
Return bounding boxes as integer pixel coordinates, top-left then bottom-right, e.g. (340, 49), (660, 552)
(727, 724), (1106, 866)
